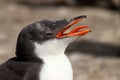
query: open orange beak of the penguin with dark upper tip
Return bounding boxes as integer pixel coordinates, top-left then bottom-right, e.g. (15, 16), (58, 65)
(56, 16), (91, 38)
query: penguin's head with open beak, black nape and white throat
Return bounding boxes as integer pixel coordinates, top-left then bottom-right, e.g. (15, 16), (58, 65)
(16, 16), (91, 57)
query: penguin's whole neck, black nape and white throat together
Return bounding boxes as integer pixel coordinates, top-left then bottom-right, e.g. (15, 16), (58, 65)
(16, 38), (73, 61)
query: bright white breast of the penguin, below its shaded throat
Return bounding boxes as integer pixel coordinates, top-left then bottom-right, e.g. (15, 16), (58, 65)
(39, 54), (73, 80)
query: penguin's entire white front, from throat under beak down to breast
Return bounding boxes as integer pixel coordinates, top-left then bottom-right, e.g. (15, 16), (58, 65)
(34, 39), (73, 80)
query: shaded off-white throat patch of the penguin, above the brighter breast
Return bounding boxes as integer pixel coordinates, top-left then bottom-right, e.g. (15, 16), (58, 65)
(34, 39), (68, 58)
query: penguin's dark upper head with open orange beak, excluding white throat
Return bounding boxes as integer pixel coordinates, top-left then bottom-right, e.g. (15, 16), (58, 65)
(19, 16), (91, 43)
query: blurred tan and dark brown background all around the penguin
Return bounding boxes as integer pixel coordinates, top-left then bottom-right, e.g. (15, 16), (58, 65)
(0, 0), (120, 80)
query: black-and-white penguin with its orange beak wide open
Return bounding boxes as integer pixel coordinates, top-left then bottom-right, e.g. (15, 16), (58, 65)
(0, 15), (91, 80)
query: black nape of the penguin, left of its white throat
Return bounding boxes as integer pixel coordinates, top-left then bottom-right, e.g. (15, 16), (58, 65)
(15, 37), (40, 62)
